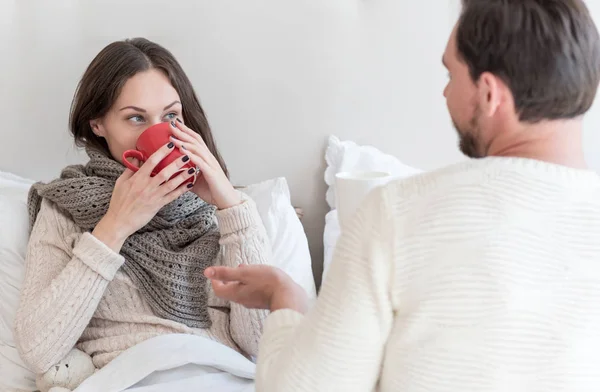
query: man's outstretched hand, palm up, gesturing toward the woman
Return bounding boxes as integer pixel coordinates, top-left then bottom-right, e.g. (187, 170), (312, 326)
(204, 264), (308, 313)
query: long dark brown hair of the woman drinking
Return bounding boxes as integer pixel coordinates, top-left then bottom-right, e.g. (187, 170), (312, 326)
(69, 38), (228, 175)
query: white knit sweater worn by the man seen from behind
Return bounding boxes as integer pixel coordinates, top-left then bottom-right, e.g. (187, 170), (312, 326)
(257, 158), (600, 392)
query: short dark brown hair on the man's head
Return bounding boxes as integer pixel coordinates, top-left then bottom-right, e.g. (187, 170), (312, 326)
(456, 0), (600, 123)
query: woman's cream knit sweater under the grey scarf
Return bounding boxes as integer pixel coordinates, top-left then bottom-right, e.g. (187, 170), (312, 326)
(15, 196), (271, 373)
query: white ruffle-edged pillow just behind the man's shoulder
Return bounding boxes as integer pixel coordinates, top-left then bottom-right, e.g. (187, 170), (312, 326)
(322, 136), (422, 280)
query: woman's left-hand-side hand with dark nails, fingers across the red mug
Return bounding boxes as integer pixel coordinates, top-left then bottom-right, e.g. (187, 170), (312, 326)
(92, 143), (194, 251)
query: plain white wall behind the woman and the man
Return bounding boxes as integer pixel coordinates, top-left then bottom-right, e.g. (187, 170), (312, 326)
(0, 0), (600, 282)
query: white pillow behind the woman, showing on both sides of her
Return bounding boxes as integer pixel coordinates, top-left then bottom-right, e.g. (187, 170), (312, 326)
(0, 172), (316, 391)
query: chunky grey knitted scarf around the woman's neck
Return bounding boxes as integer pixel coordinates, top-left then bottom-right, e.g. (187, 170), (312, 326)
(28, 149), (219, 328)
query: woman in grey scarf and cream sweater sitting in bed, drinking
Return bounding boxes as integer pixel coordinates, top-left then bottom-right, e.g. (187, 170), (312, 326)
(15, 38), (270, 382)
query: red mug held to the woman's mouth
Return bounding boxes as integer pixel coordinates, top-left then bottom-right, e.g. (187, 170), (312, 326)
(123, 122), (198, 184)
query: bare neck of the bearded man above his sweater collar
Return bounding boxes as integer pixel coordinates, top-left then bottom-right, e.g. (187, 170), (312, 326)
(487, 119), (588, 169)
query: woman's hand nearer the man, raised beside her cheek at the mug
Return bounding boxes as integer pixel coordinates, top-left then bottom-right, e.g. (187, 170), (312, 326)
(171, 119), (242, 210)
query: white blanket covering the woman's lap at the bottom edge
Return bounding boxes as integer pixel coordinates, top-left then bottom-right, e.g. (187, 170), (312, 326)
(75, 334), (255, 392)
